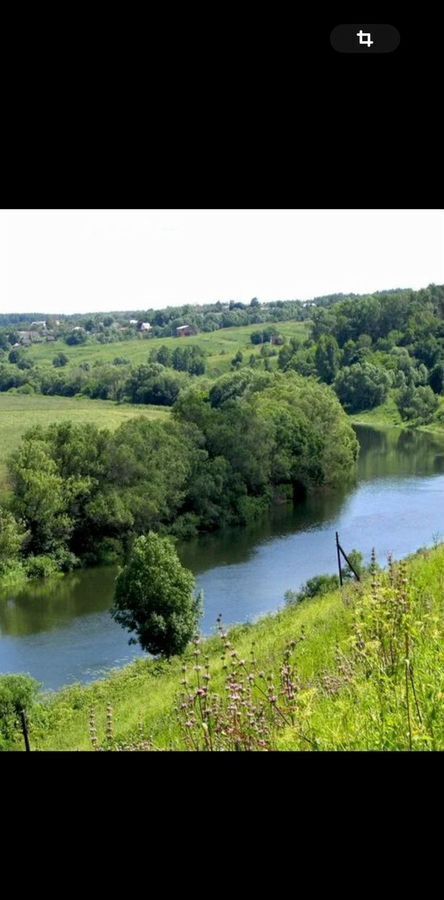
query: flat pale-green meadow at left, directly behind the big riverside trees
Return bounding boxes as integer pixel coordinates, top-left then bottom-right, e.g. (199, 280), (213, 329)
(0, 391), (169, 497)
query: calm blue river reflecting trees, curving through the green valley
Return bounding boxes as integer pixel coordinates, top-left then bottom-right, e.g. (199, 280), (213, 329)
(0, 426), (444, 690)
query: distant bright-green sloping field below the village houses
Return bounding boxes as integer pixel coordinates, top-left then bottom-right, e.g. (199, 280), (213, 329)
(26, 322), (308, 376)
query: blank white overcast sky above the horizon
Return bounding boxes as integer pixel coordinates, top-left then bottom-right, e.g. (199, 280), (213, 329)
(0, 209), (444, 313)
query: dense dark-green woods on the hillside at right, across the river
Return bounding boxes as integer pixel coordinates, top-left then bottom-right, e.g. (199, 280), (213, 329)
(279, 285), (444, 424)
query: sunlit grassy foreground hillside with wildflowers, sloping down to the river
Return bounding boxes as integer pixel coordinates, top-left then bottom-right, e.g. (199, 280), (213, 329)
(18, 545), (444, 750)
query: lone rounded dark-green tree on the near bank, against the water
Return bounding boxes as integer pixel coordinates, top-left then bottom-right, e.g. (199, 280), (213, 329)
(112, 532), (201, 658)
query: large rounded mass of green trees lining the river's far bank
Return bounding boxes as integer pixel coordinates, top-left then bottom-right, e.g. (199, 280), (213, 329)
(0, 364), (358, 571)
